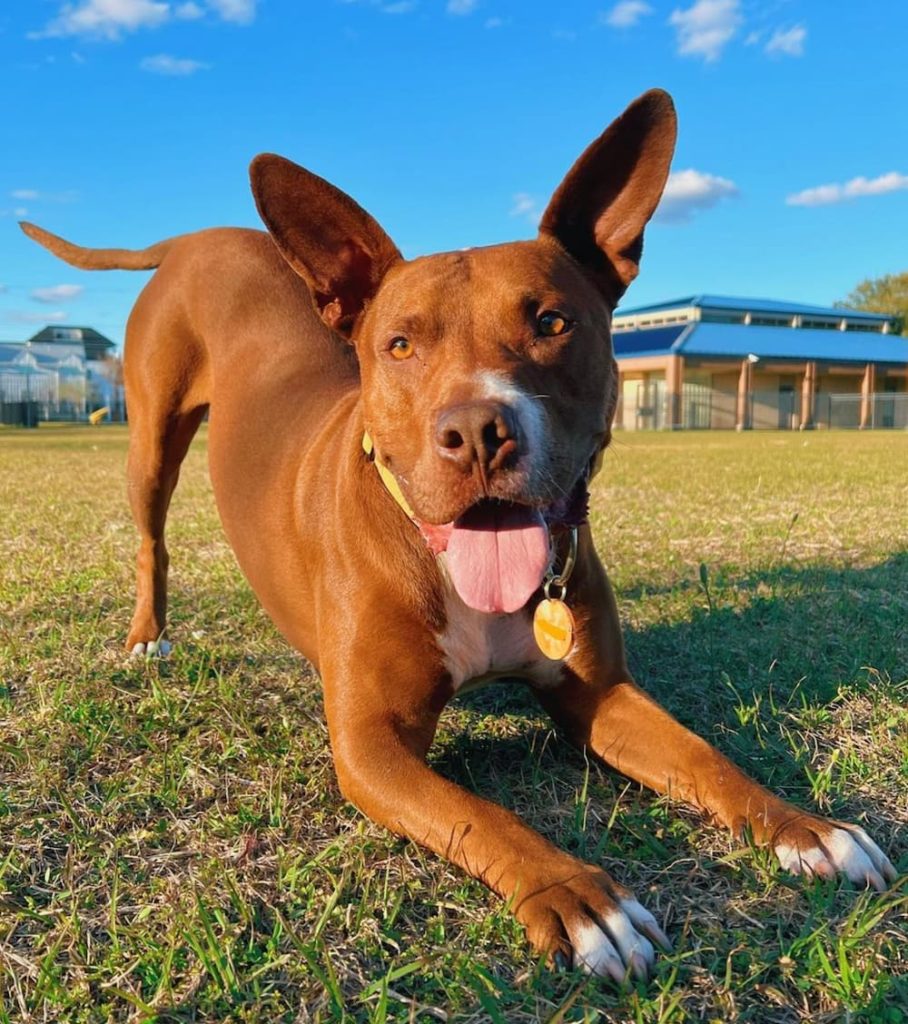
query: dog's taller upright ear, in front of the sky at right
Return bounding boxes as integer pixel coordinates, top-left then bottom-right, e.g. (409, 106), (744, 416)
(539, 89), (678, 301)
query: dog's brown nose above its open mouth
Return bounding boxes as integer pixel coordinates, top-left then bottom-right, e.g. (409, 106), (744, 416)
(435, 401), (518, 473)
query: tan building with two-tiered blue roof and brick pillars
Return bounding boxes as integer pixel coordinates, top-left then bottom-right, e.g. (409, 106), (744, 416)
(612, 295), (908, 430)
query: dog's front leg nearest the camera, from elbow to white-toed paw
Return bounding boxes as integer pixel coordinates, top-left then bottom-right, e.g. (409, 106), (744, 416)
(321, 624), (667, 980)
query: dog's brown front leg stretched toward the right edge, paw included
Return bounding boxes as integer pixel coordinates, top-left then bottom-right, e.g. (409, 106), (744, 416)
(538, 537), (896, 890)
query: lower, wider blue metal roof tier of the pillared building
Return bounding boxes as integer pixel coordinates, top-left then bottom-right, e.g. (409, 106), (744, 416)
(612, 323), (908, 364)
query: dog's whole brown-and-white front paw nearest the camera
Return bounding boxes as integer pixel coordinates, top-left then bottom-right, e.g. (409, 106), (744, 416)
(517, 864), (672, 983)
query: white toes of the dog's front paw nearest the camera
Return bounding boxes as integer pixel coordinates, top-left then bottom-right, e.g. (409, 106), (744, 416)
(569, 899), (672, 982)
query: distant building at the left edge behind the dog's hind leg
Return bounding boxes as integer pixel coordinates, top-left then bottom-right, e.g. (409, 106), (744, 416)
(0, 325), (124, 424)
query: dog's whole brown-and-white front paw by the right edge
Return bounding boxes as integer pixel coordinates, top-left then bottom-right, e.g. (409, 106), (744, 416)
(773, 815), (897, 892)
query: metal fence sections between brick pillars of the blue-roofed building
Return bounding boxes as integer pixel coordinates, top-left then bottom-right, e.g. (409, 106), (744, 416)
(615, 379), (908, 430)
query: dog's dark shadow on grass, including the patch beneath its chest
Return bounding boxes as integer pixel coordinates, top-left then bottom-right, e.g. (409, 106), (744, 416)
(434, 553), (908, 859)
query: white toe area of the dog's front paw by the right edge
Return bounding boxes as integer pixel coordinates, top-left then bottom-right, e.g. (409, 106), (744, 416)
(776, 825), (897, 892)
